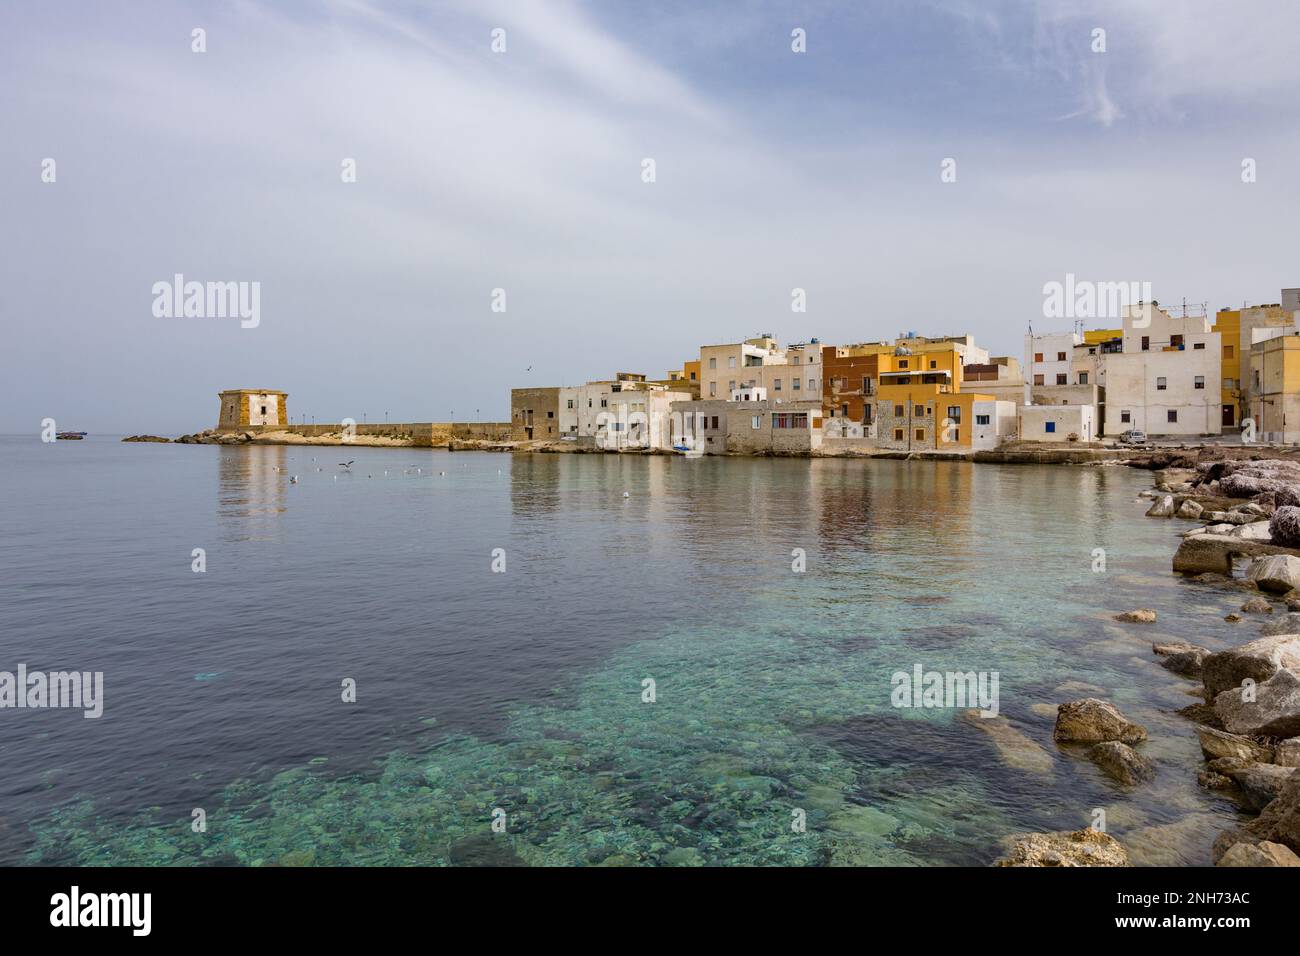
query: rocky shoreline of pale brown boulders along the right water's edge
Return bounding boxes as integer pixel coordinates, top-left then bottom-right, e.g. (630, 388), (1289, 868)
(995, 449), (1300, 866)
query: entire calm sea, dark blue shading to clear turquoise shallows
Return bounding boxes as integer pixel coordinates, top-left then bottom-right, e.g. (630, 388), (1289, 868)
(0, 437), (1253, 865)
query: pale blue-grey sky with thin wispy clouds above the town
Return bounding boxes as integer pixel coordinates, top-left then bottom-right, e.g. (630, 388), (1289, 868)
(0, 0), (1300, 434)
